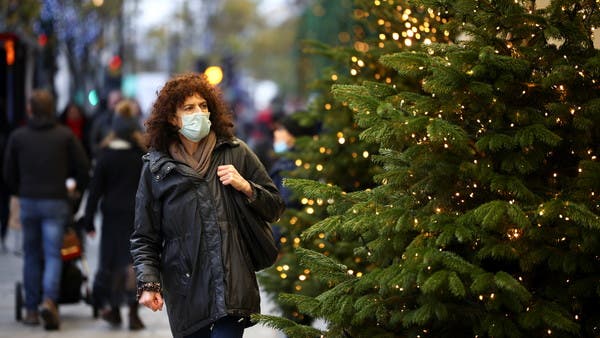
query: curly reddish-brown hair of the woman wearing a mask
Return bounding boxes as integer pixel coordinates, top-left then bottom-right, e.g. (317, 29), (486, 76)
(145, 73), (234, 152)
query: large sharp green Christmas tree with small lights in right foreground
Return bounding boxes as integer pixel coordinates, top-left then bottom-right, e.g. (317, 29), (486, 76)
(259, 0), (600, 337)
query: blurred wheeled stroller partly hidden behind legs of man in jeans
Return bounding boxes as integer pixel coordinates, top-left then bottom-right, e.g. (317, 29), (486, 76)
(15, 226), (98, 321)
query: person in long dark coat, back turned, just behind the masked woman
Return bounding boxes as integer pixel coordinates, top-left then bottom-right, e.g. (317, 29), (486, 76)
(83, 100), (145, 330)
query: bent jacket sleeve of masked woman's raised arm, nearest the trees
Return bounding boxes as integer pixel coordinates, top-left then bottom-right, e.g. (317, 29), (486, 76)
(241, 143), (285, 222)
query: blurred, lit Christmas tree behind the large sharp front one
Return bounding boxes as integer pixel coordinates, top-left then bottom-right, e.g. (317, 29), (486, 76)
(259, 0), (447, 324)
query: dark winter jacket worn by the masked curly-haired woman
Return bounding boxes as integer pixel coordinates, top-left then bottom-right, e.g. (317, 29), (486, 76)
(131, 139), (284, 337)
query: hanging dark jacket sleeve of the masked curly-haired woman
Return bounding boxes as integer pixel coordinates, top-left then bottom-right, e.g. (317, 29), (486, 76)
(130, 162), (162, 289)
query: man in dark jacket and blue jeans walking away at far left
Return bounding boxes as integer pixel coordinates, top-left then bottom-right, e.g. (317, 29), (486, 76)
(4, 90), (89, 330)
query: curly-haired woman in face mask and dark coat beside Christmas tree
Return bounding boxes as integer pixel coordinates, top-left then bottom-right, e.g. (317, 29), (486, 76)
(131, 73), (284, 338)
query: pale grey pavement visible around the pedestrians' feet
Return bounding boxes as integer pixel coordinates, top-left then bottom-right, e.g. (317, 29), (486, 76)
(0, 229), (285, 338)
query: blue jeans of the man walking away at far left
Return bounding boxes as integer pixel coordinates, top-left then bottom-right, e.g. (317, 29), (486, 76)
(19, 198), (71, 311)
